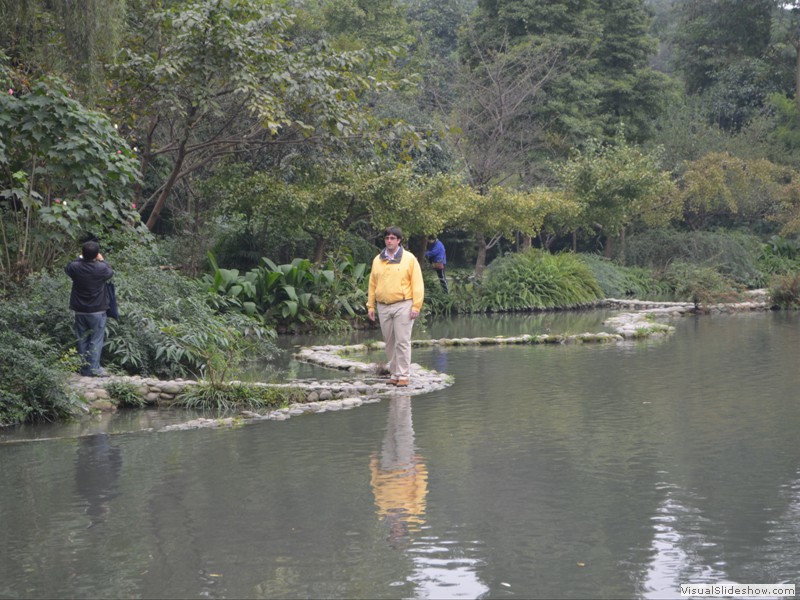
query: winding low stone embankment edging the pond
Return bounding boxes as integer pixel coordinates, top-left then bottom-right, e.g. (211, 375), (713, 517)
(70, 292), (769, 431)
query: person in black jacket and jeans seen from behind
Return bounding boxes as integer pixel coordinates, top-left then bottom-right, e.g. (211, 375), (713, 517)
(64, 241), (114, 377)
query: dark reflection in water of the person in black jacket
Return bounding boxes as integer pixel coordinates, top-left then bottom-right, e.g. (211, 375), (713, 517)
(75, 433), (122, 527)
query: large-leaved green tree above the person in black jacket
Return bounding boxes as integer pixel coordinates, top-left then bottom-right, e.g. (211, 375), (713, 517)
(0, 74), (141, 281)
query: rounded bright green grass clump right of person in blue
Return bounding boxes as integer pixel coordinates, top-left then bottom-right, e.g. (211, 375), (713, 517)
(480, 250), (604, 312)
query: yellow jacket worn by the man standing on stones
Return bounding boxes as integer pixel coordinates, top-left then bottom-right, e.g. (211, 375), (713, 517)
(367, 248), (425, 311)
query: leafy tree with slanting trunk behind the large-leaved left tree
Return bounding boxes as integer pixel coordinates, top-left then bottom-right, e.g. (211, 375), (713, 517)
(109, 0), (410, 229)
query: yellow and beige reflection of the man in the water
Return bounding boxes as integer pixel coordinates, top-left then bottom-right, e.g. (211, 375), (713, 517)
(370, 396), (428, 547)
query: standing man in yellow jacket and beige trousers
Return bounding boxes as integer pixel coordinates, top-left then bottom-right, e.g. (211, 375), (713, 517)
(367, 226), (425, 387)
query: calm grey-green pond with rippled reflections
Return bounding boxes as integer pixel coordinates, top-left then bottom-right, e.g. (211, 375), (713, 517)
(0, 312), (800, 598)
